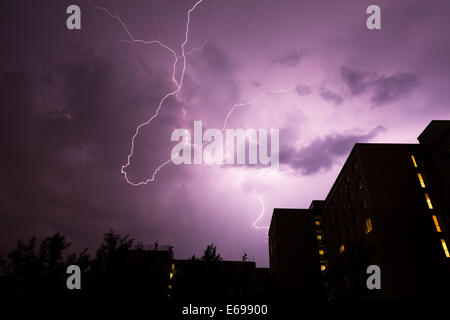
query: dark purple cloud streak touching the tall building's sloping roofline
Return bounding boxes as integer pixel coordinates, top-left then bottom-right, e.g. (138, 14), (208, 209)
(280, 126), (384, 175)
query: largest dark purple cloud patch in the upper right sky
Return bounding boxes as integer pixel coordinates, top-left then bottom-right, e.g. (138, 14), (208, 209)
(340, 66), (419, 106)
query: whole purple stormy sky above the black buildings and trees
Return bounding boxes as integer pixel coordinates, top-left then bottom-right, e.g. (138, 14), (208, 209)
(0, 0), (450, 266)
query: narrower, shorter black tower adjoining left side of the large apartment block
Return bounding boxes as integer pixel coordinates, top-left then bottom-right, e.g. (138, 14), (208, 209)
(269, 201), (327, 300)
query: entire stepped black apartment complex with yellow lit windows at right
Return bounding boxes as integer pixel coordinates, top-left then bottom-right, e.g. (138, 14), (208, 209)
(269, 121), (450, 300)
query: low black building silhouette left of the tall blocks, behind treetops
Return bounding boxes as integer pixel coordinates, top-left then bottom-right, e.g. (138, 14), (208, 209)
(101, 246), (272, 305)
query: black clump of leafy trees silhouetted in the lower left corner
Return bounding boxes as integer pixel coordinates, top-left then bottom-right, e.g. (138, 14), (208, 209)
(0, 230), (138, 302)
